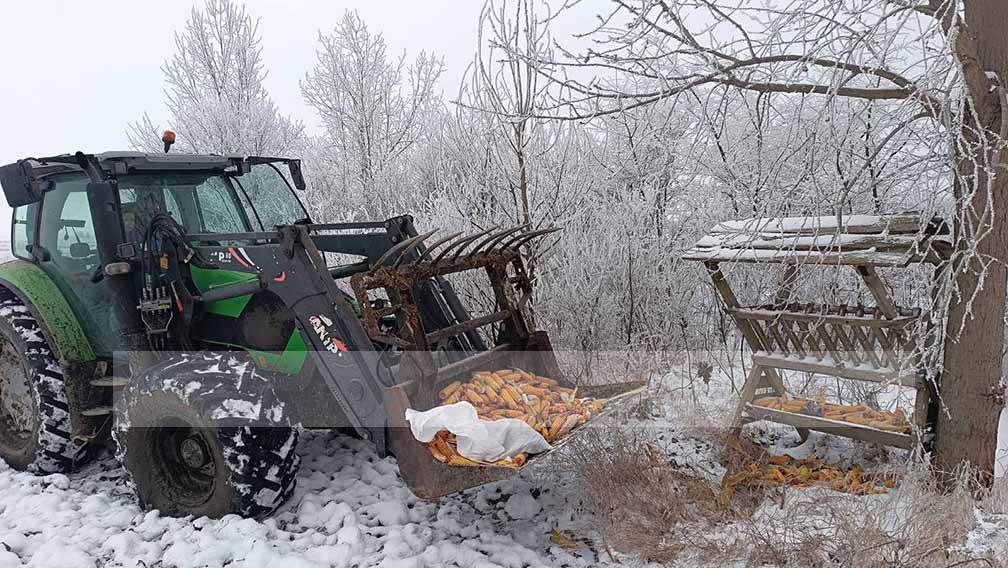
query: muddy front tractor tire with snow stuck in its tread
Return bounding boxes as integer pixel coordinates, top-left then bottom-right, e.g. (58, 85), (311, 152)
(112, 352), (300, 519)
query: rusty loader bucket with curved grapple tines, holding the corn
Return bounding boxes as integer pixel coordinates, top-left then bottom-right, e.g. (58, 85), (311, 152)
(351, 226), (644, 499)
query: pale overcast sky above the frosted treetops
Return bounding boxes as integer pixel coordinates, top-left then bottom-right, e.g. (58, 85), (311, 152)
(0, 0), (605, 239)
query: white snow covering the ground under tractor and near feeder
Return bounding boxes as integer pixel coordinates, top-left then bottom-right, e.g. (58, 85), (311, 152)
(0, 367), (1008, 568)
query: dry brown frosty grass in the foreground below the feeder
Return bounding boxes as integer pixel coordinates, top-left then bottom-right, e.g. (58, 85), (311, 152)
(568, 431), (995, 568)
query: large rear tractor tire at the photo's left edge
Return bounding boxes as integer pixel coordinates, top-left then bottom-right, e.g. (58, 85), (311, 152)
(0, 290), (94, 475)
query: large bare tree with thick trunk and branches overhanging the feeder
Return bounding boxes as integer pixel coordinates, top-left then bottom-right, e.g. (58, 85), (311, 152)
(540, 0), (1008, 480)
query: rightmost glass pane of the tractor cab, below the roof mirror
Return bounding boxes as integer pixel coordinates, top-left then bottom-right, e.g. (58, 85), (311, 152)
(235, 163), (308, 231)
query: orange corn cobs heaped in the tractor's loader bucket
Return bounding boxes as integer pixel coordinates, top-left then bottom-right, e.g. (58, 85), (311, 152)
(427, 369), (605, 469)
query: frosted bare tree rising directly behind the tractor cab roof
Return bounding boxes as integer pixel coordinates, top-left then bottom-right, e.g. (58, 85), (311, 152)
(127, 0), (304, 155)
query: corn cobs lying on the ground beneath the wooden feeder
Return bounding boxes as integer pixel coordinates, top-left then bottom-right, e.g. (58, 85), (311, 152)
(721, 456), (896, 503)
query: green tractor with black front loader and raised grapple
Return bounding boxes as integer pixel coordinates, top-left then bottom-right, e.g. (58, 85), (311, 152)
(0, 152), (634, 518)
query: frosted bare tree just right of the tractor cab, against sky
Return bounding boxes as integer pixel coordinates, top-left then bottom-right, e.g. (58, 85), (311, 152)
(301, 11), (445, 213)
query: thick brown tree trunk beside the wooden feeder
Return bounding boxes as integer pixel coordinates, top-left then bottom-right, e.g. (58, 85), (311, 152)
(934, 0), (1008, 478)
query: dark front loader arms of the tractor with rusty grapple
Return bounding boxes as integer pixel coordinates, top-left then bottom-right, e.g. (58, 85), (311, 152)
(173, 217), (559, 472)
